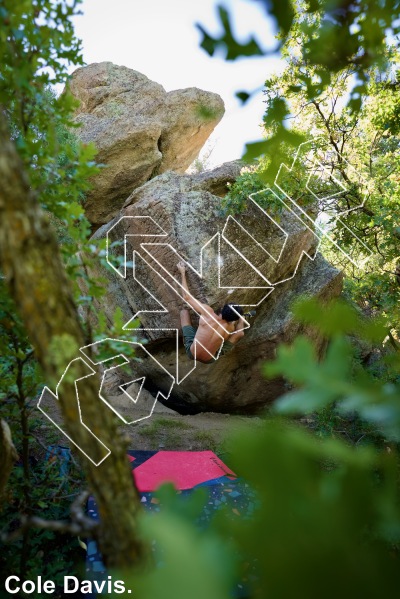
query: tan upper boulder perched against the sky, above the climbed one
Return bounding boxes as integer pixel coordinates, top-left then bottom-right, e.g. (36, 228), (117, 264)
(69, 62), (224, 226)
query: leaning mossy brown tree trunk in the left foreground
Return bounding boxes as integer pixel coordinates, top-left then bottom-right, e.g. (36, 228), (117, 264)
(0, 108), (144, 569)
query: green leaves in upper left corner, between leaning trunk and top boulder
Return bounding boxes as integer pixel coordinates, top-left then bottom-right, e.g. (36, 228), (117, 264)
(0, 0), (98, 268)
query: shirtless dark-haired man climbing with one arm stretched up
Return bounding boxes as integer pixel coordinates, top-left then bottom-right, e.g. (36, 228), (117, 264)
(178, 262), (244, 364)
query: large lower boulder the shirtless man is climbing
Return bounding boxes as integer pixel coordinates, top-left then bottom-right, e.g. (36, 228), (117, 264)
(79, 163), (342, 413)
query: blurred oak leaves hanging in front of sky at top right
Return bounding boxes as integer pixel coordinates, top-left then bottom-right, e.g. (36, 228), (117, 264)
(198, 0), (400, 182)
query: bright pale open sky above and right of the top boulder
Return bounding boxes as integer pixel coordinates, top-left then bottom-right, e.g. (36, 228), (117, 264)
(75, 0), (280, 166)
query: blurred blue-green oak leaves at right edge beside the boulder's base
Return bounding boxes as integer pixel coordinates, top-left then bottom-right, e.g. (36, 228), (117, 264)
(265, 301), (400, 441)
